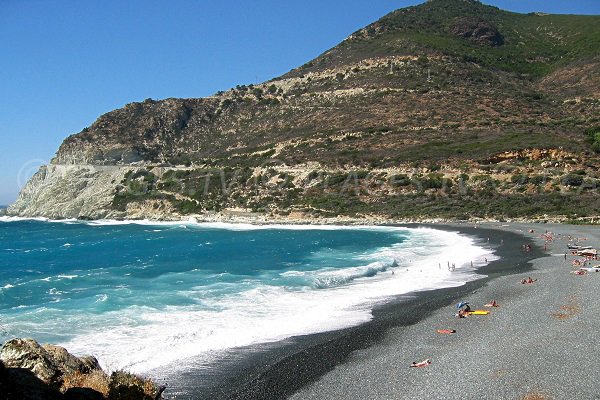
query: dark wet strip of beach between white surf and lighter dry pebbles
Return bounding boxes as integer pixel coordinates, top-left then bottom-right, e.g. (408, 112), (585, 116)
(159, 224), (542, 399)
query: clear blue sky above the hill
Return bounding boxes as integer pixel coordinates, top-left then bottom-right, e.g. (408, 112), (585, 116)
(0, 0), (600, 204)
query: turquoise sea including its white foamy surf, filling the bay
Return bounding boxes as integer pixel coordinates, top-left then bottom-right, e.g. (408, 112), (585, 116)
(0, 217), (493, 373)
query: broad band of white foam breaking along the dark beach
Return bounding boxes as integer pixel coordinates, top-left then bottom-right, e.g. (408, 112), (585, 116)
(61, 227), (495, 373)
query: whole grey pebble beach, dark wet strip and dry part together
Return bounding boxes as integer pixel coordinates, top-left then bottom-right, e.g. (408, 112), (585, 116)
(3, 220), (600, 400)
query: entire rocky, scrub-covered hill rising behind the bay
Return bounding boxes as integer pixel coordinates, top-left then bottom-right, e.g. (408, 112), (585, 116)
(8, 0), (600, 222)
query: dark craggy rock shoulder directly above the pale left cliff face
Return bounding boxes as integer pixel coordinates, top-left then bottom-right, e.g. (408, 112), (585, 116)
(52, 98), (221, 166)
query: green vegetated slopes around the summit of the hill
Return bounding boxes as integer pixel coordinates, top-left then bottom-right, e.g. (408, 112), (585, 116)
(296, 0), (600, 78)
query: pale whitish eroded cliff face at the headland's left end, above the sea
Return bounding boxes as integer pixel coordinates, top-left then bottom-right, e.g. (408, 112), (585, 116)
(7, 164), (129, 219)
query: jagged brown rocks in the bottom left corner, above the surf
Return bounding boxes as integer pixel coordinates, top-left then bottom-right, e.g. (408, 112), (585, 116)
(0, 339), (164, 400)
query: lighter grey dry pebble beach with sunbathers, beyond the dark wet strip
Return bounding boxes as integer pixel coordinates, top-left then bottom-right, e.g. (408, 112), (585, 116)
(289, 223), (600, 400)
